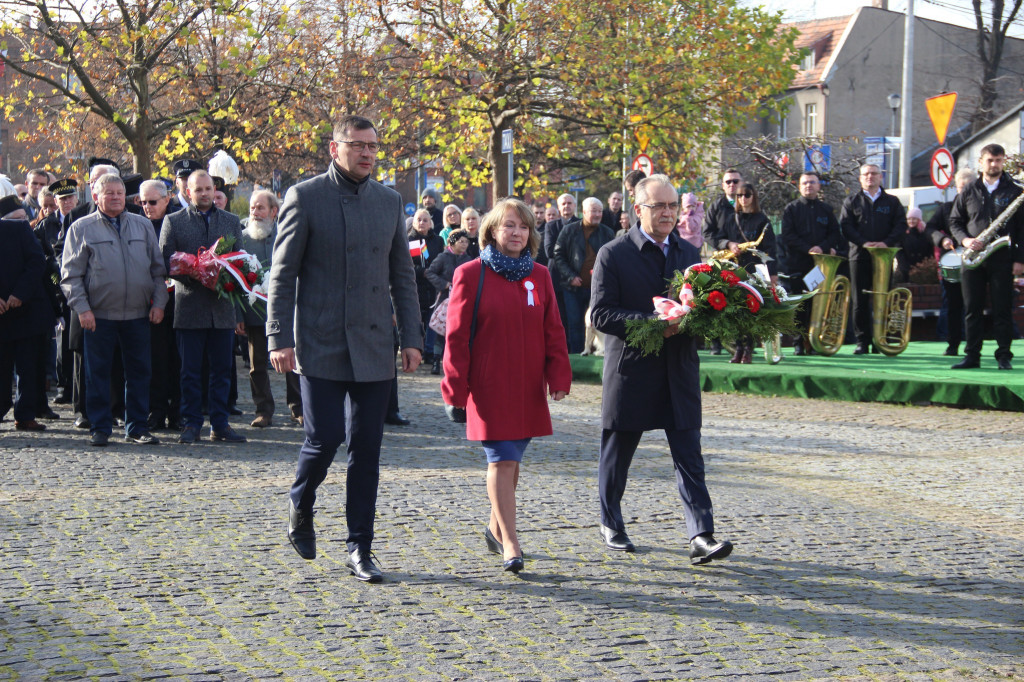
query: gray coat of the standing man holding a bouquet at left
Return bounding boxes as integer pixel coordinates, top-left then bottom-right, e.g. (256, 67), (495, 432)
(160, 204), (242, 329)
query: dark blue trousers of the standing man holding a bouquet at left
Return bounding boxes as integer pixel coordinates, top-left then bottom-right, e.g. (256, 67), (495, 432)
(175, 329), (234, 431)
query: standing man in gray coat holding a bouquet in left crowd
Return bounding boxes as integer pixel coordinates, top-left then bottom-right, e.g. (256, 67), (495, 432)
(160, 170), (246, 443)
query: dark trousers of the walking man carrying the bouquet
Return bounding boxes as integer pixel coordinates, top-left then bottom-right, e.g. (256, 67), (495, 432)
(597, 429), (715, 540)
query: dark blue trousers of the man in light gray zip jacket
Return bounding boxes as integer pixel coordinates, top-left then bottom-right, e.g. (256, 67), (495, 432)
(82, 317), (151, 435)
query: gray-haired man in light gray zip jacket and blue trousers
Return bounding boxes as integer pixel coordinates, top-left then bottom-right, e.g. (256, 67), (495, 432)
(60, 173), (167, 445)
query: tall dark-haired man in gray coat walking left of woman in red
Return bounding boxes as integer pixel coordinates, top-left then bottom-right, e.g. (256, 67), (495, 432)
(266, 116), (423, 583)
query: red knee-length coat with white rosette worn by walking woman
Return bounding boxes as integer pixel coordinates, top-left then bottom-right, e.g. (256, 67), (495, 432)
(441, 259), (572, 440)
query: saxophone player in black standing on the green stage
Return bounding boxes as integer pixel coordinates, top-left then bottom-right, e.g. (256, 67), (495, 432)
(949, 144), (1024, 370)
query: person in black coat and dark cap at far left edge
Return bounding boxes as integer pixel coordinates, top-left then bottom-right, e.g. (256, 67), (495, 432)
(0, 195), (54, 431)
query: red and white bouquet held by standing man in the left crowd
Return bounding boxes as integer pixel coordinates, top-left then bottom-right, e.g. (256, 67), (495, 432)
(170, 237), (269, 316)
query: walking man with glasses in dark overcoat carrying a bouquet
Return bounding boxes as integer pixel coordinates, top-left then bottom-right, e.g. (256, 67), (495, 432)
(591, 175), (732, 564)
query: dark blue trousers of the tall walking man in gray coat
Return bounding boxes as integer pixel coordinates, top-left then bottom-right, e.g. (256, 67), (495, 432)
(291, 377), (391, 552)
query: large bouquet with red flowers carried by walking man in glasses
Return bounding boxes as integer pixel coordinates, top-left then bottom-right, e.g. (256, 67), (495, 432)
(626, 259), (814, 355)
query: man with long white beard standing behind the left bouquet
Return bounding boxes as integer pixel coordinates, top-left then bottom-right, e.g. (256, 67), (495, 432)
(239, 189), (302, 427)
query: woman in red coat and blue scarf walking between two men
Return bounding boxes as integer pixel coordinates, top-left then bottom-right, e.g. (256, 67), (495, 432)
(441, 199), (572, 572)
